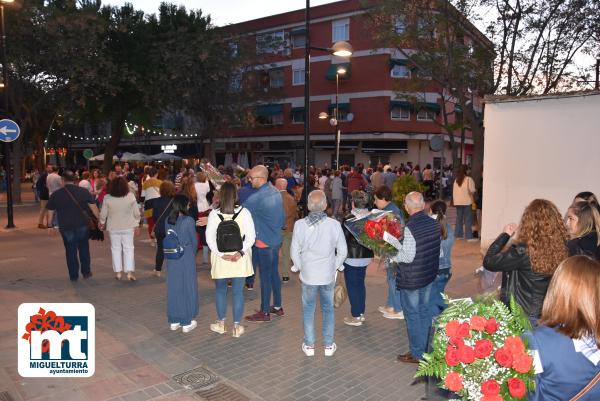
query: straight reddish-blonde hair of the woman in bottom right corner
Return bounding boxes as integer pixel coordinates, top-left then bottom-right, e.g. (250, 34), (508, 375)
(540, 255), (600, 346)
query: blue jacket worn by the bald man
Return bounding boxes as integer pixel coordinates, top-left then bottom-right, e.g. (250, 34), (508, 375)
(242, 183), (285, 247)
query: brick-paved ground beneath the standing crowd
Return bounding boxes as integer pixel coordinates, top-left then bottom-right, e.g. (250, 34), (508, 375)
(0, 206), (481, 401)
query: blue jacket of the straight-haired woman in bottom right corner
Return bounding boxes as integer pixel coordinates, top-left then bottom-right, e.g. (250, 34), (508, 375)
(525, 326), (600, 401)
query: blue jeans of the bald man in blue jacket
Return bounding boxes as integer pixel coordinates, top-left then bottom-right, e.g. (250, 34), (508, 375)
(252, 246), (281, 313)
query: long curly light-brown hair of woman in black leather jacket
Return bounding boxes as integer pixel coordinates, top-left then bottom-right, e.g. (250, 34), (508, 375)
(518, 199), (569, 274)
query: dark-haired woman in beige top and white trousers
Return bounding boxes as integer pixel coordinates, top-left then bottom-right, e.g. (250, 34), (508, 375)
(100, 177), (140, 281)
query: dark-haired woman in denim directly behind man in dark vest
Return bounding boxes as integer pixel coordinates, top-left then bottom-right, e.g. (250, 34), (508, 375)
(430, 200), (454, 316)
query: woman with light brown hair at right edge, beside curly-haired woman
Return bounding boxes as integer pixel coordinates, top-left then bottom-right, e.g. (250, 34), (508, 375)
(566, 201), (600, 261)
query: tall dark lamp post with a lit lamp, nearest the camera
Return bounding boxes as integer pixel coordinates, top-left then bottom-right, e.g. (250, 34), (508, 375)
(302, 0), (354, 216)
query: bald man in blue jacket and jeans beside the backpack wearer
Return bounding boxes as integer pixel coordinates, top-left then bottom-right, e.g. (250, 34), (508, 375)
(243, 165), (285, 322)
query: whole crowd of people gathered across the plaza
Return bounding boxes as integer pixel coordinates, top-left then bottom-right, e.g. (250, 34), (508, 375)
(37, 158), (600, 399)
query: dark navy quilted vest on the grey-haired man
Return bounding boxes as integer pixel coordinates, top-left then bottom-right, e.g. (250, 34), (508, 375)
(396, 212), (441, 290)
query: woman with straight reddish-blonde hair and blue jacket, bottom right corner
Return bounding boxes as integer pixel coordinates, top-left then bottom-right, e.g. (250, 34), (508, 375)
(526, 256), (600, 401)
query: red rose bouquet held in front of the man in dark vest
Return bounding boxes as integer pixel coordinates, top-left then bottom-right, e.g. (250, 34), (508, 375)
(344, 209), (403, 256)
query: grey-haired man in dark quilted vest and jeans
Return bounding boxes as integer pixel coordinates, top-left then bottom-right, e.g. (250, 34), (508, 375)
(393, 192), (441, 363)
